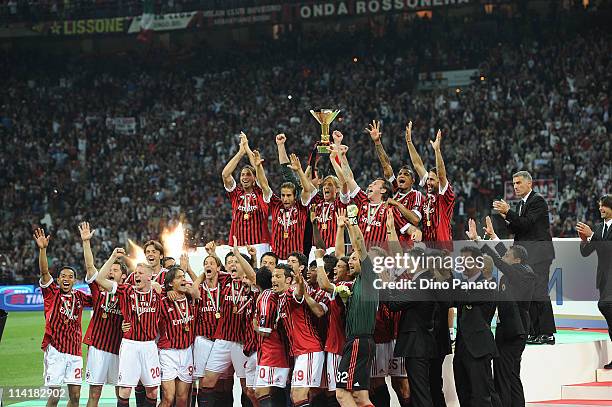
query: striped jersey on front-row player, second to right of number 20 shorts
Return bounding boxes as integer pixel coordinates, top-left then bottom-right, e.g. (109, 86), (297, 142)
(195, 273), (231, 339)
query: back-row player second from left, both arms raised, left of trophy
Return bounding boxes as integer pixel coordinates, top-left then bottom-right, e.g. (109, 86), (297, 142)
(253, 142), (317, 260)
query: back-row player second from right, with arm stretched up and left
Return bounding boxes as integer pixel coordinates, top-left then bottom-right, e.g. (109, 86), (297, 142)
(366, 120), (425, 241)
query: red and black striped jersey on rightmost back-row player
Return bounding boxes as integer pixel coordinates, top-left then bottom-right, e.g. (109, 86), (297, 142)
(421, 181), (455, 245)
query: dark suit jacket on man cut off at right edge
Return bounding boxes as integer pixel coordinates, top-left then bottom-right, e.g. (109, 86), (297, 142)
(580, 222), (612, 301)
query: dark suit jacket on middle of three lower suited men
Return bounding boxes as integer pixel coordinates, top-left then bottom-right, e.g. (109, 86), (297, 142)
(455, 275), (498, 358)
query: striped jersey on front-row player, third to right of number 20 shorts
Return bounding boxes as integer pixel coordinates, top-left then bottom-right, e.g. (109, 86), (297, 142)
(213, 278), (252, 343)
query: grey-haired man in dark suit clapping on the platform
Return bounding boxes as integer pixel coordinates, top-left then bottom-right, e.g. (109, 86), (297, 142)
(493, 171), (557, 345)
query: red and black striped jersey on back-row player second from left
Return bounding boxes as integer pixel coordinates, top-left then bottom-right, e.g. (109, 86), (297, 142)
(270, 193), (314, 260)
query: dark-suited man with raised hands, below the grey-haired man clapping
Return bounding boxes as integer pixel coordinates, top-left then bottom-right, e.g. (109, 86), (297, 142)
(468, 216), (536, 407)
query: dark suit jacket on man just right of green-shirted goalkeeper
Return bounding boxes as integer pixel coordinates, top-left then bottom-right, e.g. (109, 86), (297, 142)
(389, 271), (438, 359)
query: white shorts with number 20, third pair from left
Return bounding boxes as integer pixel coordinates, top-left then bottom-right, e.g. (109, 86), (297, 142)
(117, 338), (161, 387)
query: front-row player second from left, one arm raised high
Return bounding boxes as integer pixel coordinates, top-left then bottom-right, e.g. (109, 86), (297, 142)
(79, 222), (128, 407)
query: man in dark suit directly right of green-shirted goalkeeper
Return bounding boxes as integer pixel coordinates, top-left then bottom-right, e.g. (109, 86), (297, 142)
(388, 248), (438, 407)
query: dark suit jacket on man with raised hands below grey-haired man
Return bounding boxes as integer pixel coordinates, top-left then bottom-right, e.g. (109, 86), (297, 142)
(482, 243), (536, 344)
